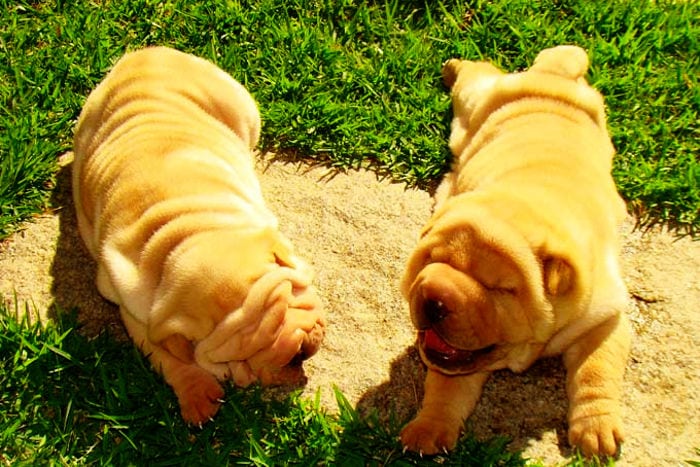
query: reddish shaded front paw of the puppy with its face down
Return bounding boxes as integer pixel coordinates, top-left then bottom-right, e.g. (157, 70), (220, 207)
(175, 371), (224, 426)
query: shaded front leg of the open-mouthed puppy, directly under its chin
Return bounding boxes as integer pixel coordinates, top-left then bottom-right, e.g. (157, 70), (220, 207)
(401, 369), (489, 454)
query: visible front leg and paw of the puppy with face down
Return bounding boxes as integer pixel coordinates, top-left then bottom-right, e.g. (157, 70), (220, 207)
(120, 307), (224, 425)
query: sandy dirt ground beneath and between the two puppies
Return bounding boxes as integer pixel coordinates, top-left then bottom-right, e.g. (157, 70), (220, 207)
(0, 155), (700, 466)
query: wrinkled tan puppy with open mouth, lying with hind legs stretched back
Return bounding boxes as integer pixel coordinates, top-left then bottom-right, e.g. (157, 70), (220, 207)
(401, 46), (630, 455)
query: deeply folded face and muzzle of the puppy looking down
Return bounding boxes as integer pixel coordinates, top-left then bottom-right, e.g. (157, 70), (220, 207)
(195, 230), (325, 386)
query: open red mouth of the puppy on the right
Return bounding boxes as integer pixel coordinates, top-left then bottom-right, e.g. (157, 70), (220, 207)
(418, 329), (496, 371)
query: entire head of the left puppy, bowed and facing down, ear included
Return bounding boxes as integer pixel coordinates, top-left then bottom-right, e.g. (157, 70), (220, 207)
(150, 228), (325, 386)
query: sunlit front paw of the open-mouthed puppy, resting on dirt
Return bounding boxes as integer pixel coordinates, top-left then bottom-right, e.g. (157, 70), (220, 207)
(569, 414), (623, 457)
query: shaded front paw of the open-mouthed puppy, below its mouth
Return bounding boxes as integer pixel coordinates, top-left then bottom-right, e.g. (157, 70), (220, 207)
(401, 414), (461, 455)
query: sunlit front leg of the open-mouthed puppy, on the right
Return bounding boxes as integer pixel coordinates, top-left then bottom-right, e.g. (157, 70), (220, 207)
(564, 314), (631, 457)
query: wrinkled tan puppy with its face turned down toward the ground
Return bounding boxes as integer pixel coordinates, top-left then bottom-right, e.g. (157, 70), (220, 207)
(73, 47), (324, 424)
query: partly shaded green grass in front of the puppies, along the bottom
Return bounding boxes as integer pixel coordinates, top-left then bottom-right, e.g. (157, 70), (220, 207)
(0, 307), (525, 466)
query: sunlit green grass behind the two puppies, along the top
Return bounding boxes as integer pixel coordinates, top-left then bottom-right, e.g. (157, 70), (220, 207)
(0, 0), (700, 238)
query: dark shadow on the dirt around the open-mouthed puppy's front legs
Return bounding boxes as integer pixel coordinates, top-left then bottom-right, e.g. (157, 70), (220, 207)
(357, 347), (572, 456)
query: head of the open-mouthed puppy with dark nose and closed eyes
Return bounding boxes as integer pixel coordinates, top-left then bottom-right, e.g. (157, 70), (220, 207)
(402, 197), (571, 374)
